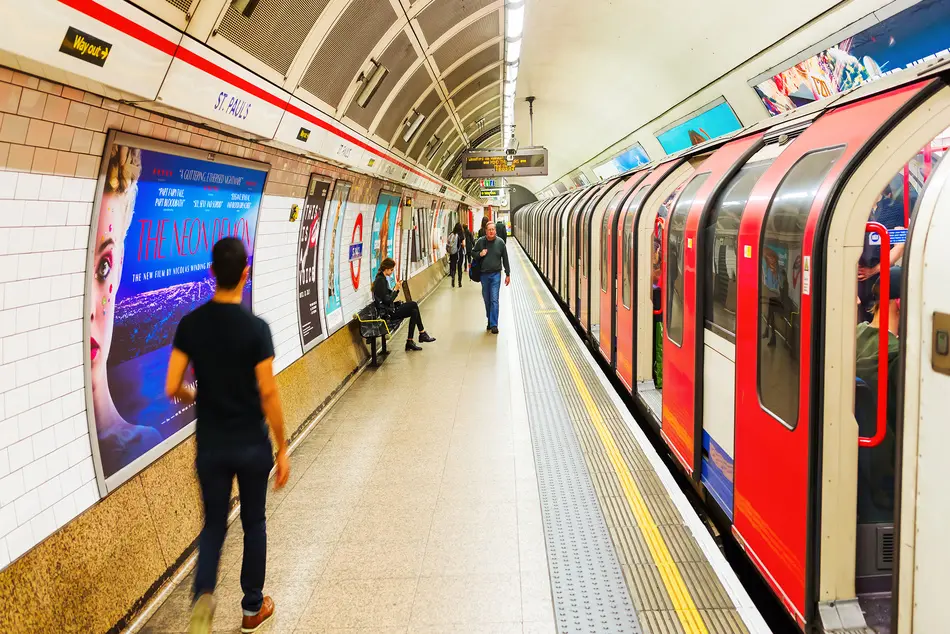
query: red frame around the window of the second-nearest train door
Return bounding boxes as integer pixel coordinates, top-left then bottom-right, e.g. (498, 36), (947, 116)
(660, 134), (762, 478)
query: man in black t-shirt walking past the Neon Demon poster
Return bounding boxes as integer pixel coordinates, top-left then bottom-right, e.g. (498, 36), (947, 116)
(165, 238), (290, 634)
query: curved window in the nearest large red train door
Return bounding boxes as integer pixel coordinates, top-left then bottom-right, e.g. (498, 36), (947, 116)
(758, 147), (844, 429)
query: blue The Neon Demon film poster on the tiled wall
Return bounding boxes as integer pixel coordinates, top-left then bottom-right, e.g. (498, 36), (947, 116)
(84, 132), (268, 494)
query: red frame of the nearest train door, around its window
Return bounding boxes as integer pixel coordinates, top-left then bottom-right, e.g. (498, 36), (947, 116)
(732, 82), (926, 628)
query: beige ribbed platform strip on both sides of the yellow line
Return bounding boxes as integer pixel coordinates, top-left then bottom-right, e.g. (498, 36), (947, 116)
(513, 249), (748, 634)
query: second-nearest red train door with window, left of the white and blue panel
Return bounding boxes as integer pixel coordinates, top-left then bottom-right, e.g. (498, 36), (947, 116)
(661, 135), (762, 482)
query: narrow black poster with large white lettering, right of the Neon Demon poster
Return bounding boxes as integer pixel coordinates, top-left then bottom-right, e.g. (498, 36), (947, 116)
(297, 174), (330, 352)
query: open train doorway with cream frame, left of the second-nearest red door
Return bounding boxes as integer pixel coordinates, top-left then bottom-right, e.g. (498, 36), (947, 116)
(633, 158), (702, 428)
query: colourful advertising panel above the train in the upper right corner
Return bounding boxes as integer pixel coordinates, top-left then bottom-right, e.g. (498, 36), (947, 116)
(755, 0), (950, 116)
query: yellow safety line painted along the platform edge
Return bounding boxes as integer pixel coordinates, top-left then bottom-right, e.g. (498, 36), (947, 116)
(525, 246), (709, 634)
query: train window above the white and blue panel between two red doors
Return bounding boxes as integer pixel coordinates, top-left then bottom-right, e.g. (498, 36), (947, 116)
(703, 159), (773, 343)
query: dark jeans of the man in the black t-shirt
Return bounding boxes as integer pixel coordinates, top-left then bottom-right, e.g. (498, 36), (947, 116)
(194, 441), (274, 613)
